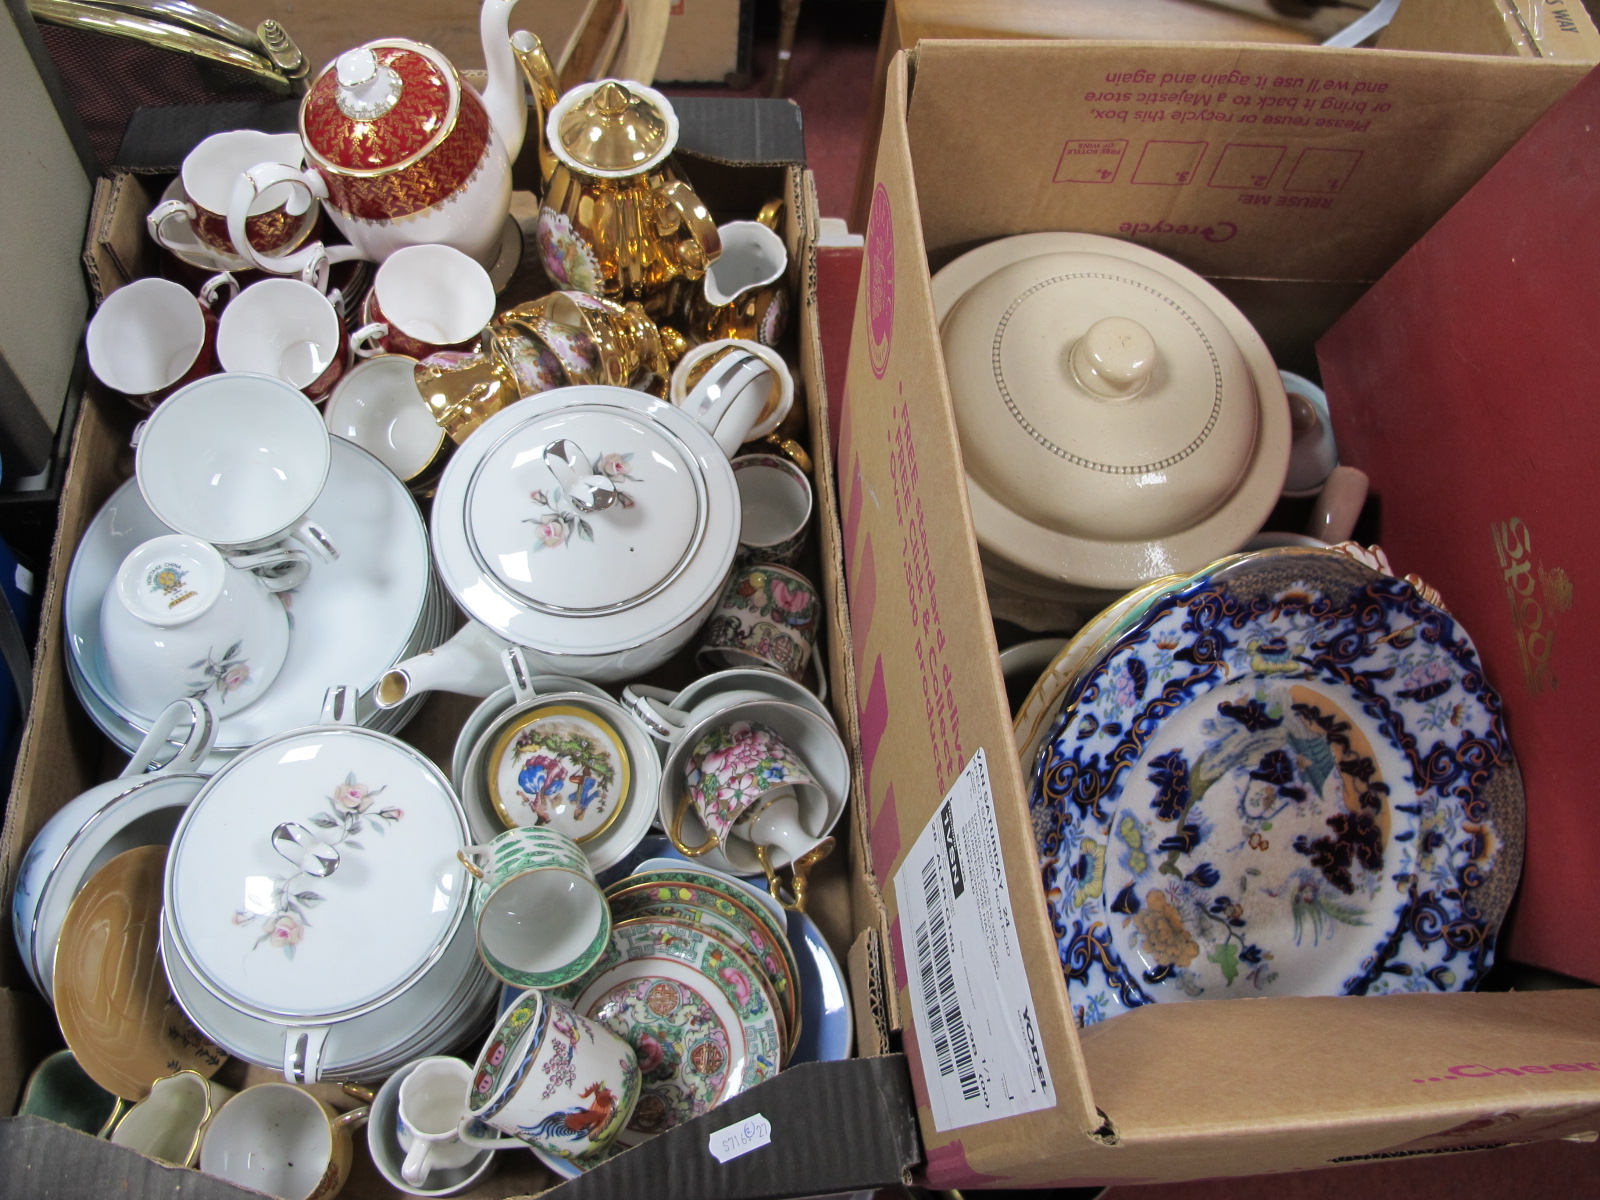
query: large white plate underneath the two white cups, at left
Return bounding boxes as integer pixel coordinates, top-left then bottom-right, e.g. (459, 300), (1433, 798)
(64, 437), (442, 750)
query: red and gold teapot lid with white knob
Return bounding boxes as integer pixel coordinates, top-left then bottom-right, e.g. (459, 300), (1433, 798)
(301, 38), (461, 174)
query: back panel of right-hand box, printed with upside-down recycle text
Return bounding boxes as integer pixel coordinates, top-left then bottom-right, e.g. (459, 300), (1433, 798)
(890, 42), (1587, 280)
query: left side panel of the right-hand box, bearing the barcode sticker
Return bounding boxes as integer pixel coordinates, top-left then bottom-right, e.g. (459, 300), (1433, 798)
(837, 56), (1101, 1141)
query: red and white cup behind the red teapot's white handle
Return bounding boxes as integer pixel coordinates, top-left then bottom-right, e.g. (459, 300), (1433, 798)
(146, 130), (320, 269)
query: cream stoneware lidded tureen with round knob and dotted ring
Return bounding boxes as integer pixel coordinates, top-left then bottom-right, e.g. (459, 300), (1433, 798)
(933, 234), (1290, 627)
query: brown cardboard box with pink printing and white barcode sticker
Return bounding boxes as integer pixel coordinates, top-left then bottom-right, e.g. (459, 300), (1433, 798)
(838, 42), (1600, 1187)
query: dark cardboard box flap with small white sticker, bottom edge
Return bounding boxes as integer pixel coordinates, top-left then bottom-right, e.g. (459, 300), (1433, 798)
(549, 1054), (922, 1200)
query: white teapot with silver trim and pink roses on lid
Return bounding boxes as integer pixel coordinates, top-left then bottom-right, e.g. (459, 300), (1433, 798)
(378, 354), (771, 707)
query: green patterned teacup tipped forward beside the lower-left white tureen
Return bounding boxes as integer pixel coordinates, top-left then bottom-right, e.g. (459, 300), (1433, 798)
(456, 829), (611, 987)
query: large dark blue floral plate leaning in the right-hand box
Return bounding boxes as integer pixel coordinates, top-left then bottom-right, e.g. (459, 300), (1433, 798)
(1030, 549), (1523, 1024)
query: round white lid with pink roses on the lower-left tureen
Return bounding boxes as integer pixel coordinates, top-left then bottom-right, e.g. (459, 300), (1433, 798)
(165, 725), (470, 1019)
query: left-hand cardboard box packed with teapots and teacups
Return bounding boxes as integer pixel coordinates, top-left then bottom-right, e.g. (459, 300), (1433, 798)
(0, 99), (920, 1200)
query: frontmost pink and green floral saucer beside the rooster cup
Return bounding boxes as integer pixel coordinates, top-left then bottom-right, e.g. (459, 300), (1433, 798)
(552, 922), (782, 1147)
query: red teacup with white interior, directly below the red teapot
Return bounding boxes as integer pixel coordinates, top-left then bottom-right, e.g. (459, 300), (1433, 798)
(357, 245), (494, 358)
